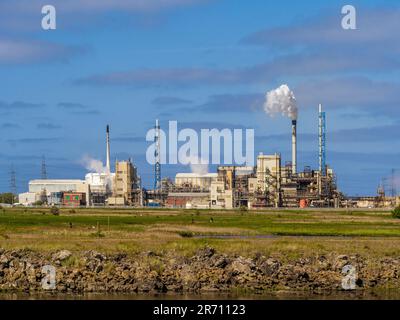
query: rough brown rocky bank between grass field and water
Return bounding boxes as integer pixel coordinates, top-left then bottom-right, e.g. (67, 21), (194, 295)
(0, 247), (400, 293)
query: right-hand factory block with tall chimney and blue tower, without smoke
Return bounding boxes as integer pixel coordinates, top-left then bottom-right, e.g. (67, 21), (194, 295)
(162, 106), (341, 209)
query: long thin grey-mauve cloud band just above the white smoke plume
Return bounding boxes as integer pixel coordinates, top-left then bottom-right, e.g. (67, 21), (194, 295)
(74, 51), (400, 88)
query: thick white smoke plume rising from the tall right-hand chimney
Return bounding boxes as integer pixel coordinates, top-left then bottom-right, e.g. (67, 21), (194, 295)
(264, 84), (298, 120)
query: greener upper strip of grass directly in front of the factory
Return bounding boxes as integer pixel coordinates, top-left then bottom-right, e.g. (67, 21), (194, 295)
(0, 209), (400, 237)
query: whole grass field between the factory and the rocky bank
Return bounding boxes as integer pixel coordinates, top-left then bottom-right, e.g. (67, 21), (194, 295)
(0, 208), (400, 258)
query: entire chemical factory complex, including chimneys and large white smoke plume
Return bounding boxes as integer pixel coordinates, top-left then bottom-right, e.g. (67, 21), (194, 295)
(14, 85), (399, 209)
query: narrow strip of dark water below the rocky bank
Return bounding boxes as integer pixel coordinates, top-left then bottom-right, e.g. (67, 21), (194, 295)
(0, 289), (400, 300)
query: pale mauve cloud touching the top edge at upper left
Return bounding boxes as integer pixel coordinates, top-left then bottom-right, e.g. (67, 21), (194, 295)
(0, 0), (212, 33)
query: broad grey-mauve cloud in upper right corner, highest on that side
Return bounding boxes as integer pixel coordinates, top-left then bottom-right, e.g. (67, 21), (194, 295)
(241, 7), (400, 50)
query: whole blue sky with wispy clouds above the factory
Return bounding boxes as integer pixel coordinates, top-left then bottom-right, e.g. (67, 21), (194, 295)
(0, 0), (400, 195)
